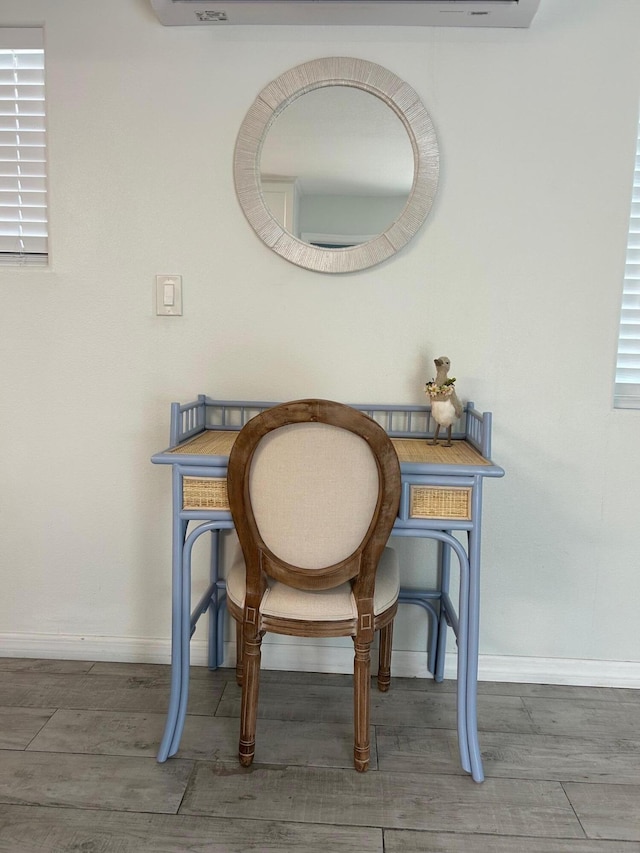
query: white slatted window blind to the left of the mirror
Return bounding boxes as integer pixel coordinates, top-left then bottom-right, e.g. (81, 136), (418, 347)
(0, 28), (48, 263)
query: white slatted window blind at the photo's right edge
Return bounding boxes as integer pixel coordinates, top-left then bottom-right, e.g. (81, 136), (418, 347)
(615, 112), (640, 409)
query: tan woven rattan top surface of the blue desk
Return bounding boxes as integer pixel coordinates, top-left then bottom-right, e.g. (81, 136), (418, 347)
(169, 429), (489, 465)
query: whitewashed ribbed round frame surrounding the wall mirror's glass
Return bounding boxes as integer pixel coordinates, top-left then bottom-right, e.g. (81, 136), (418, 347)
(233, 56), (439, 273)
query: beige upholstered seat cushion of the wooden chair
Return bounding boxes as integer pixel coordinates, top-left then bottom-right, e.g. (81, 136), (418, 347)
(227, 548), (400, 621)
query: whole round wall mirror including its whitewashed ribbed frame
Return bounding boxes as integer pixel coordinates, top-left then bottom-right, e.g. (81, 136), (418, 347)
(234, 57), (439, 273)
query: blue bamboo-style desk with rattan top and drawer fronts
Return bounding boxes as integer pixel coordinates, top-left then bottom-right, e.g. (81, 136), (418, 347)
(151, 395), (504, 782)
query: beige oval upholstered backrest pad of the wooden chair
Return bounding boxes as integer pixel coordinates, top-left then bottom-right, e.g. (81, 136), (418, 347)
(249, 423), (378, 569)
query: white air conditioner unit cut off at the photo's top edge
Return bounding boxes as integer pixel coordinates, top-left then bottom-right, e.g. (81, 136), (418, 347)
(151, 0), (540, 27)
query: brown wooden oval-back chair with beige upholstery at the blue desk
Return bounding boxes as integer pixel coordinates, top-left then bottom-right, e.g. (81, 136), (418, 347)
(227, 400), (400, 771)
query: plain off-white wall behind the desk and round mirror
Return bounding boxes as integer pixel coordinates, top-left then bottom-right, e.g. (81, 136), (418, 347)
(0, 0), (640, 684)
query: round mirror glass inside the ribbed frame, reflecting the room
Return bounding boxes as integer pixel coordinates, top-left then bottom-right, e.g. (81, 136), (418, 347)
(260, 85), (414, 248)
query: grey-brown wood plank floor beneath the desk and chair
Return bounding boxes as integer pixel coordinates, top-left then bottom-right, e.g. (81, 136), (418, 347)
(0, 658), (640, 853)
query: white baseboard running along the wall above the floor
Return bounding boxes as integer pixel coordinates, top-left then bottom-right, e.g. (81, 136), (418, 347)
(0, 634), (640, 688)
